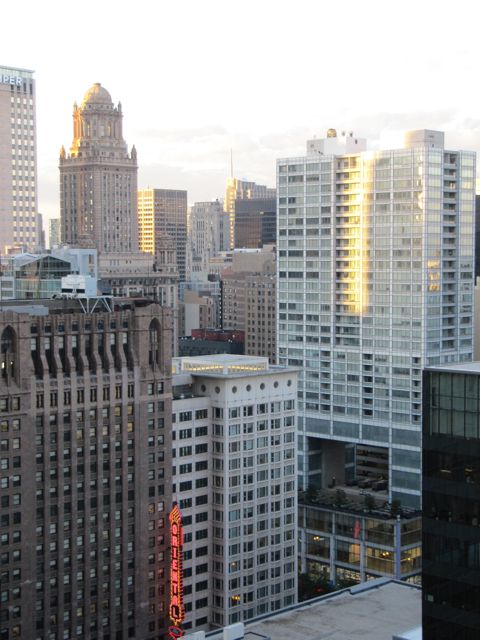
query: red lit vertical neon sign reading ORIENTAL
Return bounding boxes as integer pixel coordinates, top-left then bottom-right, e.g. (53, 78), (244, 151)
(168, 503), (185, 639)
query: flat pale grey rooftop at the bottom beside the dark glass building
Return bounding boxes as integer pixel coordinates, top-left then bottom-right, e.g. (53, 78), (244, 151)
(219, 580), (422, 640)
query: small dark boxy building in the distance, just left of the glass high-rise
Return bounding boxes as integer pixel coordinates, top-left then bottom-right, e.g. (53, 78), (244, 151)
(235, 198), (277, 249)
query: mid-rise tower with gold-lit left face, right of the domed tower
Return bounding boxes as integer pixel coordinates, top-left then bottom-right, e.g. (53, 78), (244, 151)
(138, 189), (187, 282)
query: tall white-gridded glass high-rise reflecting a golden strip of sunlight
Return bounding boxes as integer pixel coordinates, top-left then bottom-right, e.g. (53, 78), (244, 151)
(277, 131), (475, 508)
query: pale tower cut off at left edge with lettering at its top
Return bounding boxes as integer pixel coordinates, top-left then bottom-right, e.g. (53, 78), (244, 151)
(0, 66), (39, 255)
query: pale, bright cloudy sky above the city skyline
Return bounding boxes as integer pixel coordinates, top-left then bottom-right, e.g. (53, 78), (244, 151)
(0, 0), (480, 228)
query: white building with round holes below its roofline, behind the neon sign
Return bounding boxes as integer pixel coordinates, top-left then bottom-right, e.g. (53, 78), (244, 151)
(172, 354), (297, 629)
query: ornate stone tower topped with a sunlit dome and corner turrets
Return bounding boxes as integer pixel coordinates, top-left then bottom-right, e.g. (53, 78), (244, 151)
(60, 82), (138, 253)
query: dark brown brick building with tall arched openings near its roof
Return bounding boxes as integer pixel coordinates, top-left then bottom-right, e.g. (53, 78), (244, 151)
(0, 297), (171, 640)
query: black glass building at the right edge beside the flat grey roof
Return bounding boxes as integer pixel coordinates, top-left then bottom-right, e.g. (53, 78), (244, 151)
(422, 362), (480, 640)
